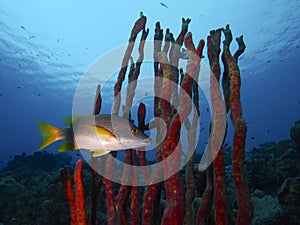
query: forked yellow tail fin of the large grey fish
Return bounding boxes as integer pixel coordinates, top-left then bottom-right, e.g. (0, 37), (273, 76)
(37, 120), (62, 150)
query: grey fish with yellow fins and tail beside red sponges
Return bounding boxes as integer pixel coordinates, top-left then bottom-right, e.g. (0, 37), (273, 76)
(37, 114), (152, 157)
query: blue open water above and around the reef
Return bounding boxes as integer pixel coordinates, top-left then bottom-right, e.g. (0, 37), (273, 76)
(0, 0), (300, 167)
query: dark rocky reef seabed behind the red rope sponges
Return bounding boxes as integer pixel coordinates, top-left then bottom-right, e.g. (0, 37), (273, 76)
(0, 118), (300, 225)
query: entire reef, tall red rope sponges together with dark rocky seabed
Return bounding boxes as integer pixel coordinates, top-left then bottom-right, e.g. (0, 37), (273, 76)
(0, 13), (300, 225)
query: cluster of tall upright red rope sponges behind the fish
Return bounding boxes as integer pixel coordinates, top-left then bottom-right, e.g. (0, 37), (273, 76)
(61, 13), (253, 225)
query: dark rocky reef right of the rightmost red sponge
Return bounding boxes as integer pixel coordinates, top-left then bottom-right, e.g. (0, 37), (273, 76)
(246, 140), (300, 225)
